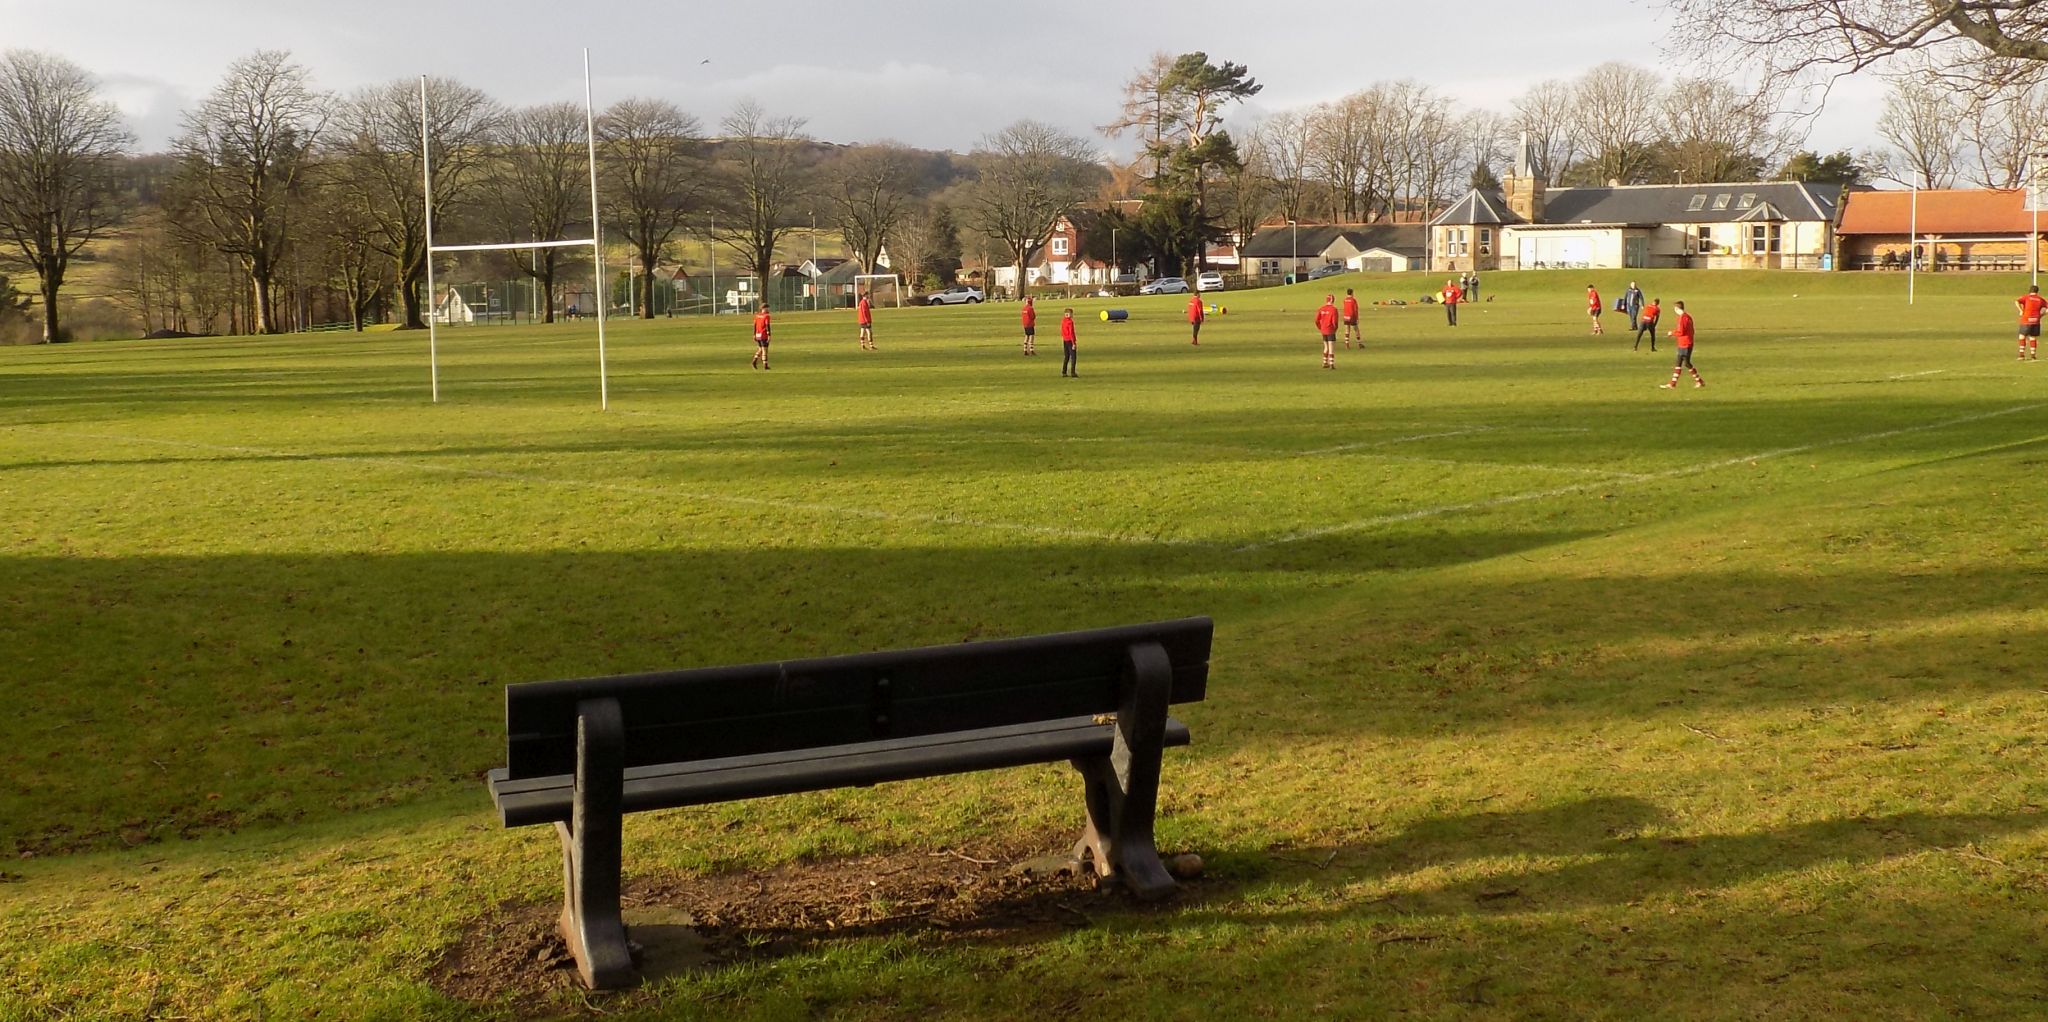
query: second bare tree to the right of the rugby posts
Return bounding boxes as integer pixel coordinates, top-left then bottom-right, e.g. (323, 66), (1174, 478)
(713, 100), (811, 295)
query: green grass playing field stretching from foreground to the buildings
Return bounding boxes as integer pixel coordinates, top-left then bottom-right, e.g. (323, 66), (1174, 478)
(0, 272), (2048, 1020)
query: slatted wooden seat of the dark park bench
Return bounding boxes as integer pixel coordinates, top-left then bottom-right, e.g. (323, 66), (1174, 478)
(489, 717), (1190, 827)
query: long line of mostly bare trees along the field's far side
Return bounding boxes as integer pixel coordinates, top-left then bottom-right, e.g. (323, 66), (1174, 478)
(0, 20), (2048, 340)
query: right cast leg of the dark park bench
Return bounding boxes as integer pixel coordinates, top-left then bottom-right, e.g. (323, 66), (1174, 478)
(1073, 643), (1176, 901)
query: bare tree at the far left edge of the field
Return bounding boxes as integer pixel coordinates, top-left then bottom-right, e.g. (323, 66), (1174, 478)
(0, 49), (135, 344)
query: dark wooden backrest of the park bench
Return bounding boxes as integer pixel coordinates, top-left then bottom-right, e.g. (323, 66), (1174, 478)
(506, 616), (1212, 778)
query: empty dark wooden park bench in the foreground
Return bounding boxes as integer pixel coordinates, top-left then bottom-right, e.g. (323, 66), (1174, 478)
(487, 619), (1212, 989)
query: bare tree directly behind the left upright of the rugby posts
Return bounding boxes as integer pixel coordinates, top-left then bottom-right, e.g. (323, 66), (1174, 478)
(332, 78), (502, 330)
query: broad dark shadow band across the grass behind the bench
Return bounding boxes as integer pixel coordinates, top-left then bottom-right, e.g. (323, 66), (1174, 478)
(0, 522), (2048, 864)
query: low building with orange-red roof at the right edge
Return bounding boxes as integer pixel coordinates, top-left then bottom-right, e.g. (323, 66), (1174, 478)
(1835, 188), (2042, 270)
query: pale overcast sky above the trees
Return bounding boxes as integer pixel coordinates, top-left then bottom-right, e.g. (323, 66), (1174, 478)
(0, 0), (1882, 165)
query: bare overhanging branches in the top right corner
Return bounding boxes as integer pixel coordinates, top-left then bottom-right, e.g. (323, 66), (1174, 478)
(1663, 0), (2048, 86)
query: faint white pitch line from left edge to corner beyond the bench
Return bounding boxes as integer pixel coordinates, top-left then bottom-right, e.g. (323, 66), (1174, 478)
(12, 426), (1194, 547)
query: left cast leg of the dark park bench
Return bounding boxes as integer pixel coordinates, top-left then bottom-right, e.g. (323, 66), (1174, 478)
(555, 698), (639, 989)
